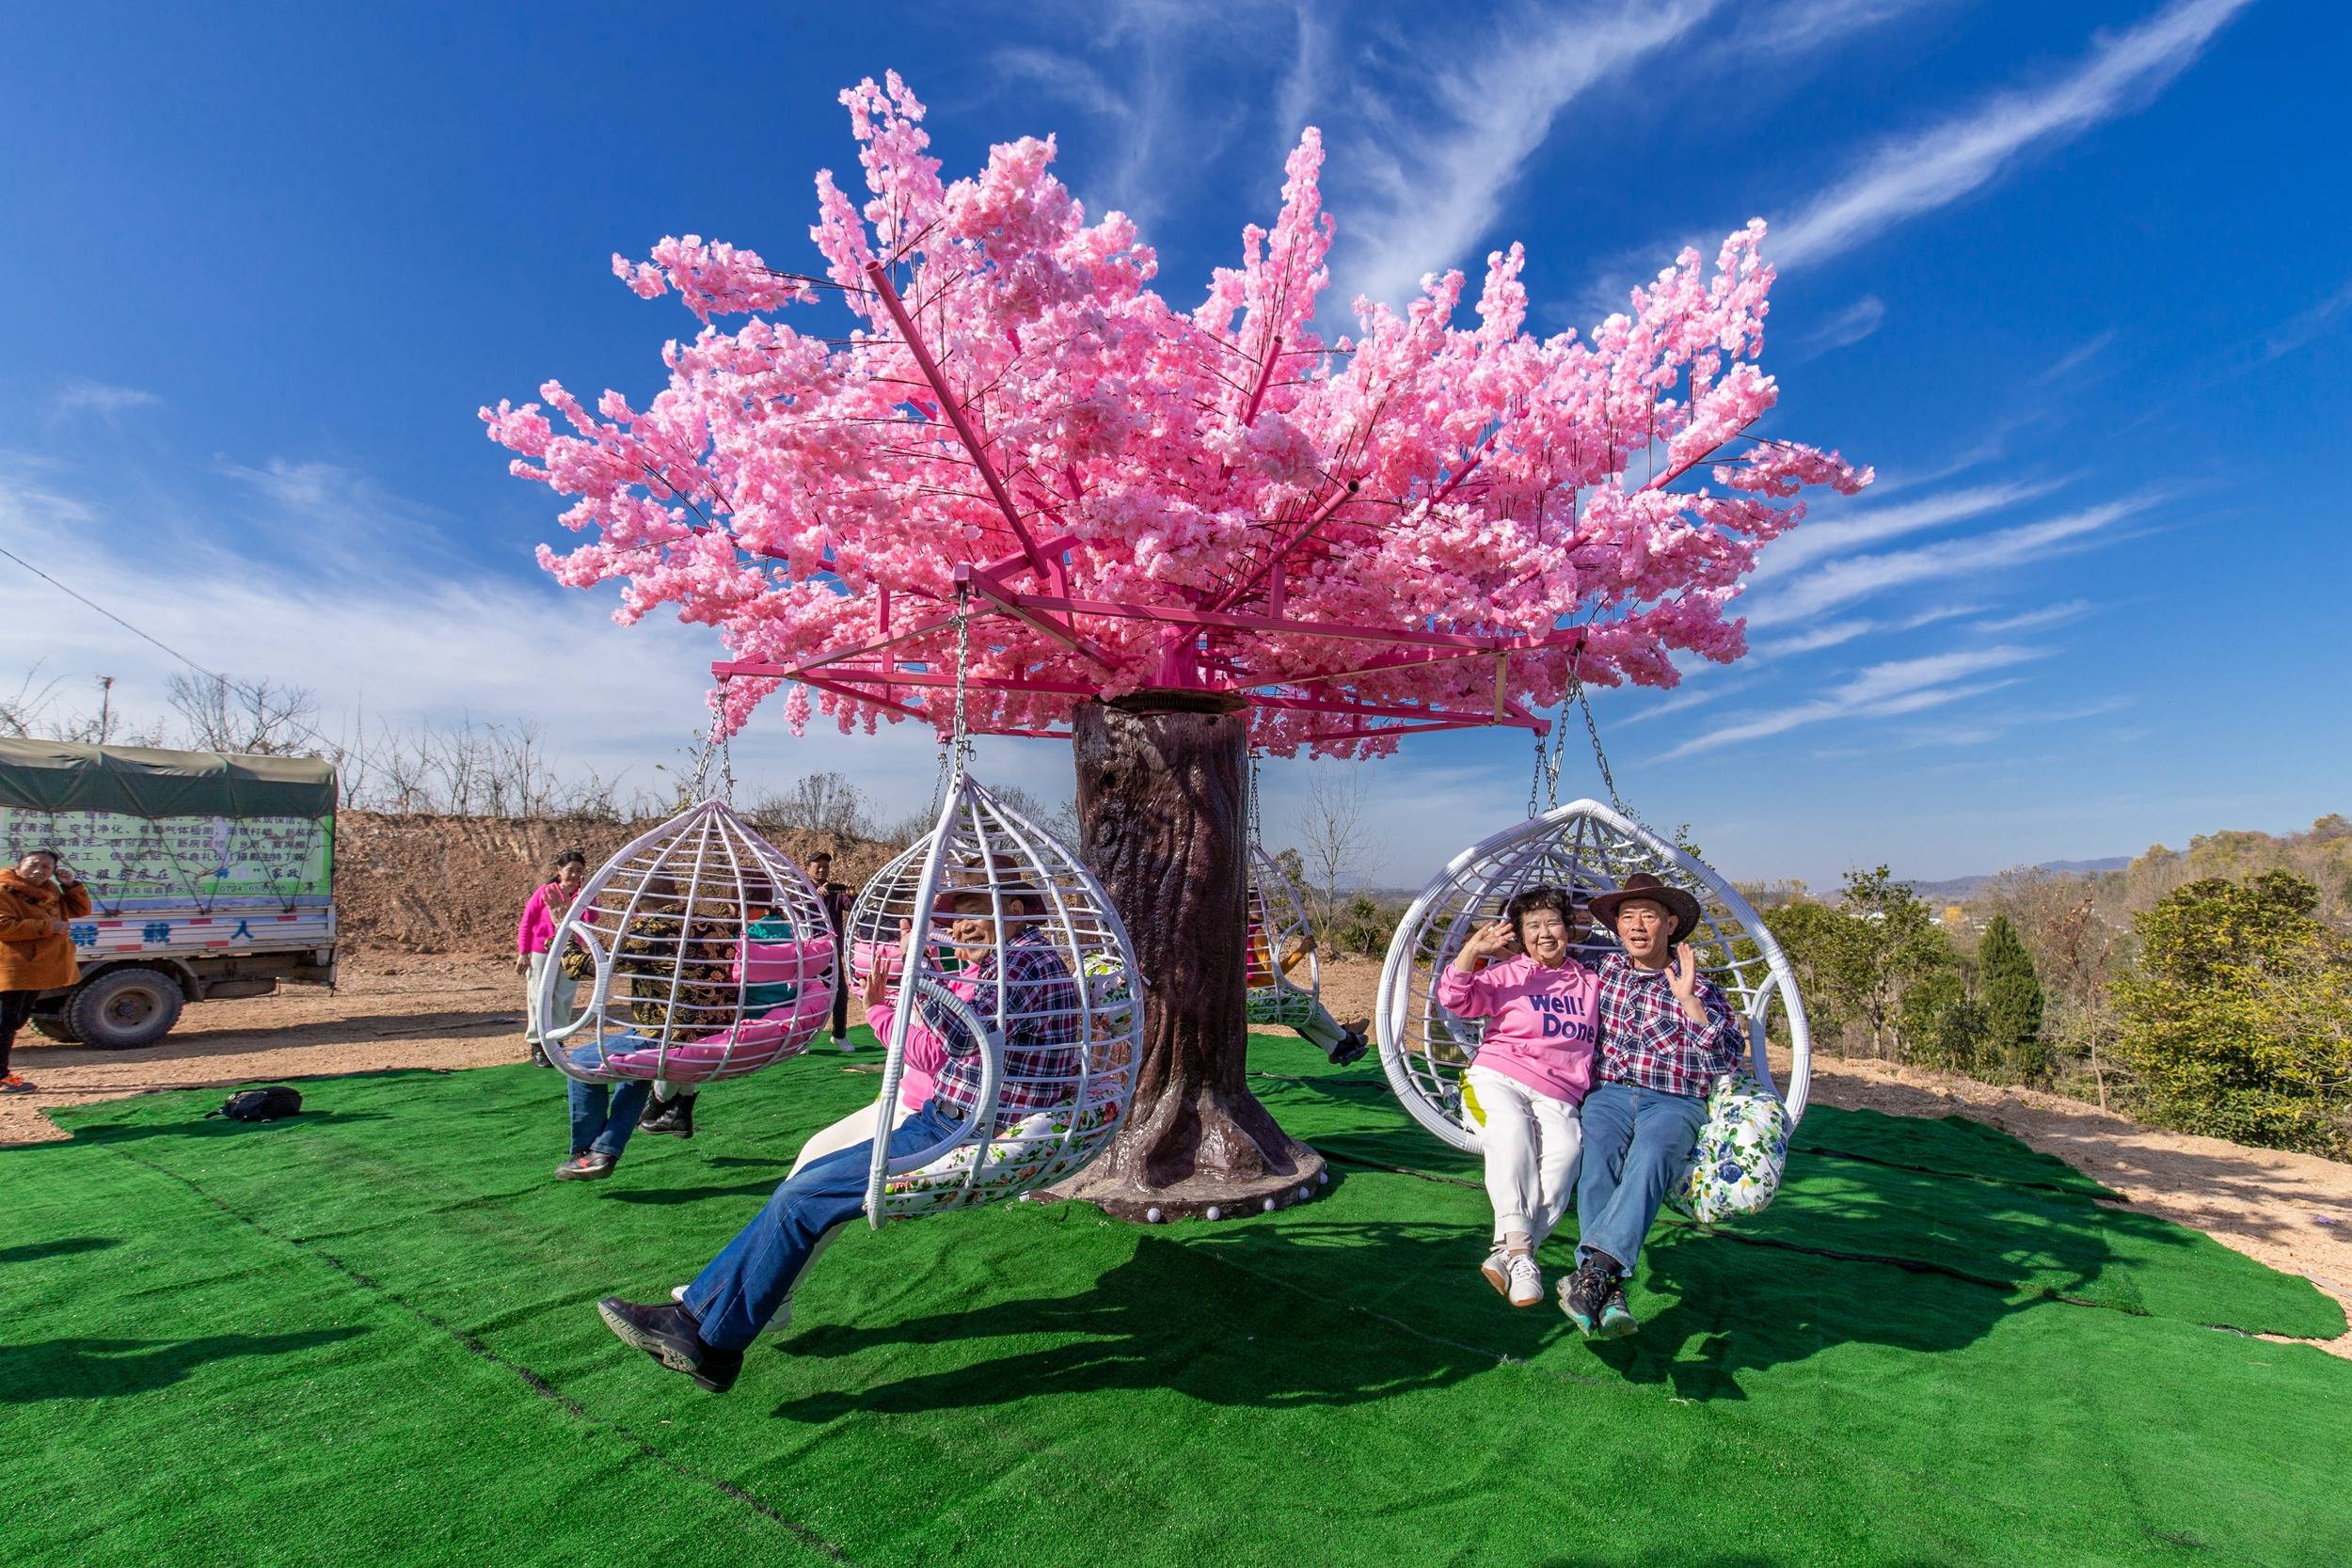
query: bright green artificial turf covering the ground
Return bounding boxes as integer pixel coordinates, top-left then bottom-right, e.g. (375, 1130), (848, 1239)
(0, 1037), (2352, 1568)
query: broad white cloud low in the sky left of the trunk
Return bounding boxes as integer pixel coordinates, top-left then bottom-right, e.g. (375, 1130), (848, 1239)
(0, 455), (964, 816)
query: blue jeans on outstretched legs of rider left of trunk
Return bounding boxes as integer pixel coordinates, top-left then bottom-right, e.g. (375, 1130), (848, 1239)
(687, 1101), (962, 1350)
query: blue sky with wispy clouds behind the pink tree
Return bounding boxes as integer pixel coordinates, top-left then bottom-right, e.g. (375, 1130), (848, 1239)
(0, 0), (2352, 884)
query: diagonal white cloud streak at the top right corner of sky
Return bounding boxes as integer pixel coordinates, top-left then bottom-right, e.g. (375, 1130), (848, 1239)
(1772, 0), (2251, 265)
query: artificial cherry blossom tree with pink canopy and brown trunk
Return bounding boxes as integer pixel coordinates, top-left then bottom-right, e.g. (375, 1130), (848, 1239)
(483, 75), (1870, 1213)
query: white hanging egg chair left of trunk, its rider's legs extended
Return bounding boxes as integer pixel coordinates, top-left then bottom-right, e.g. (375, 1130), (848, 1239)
(850, 776), (1143, 1227)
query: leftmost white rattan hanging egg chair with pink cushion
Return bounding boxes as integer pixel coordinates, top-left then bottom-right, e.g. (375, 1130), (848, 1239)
(536, 800), (835, 1084)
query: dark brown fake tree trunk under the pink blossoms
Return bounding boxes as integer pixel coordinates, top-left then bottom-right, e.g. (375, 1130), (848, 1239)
(1058, 691), (1325, 1220)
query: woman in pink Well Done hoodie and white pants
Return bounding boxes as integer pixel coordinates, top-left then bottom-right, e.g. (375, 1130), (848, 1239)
(1438, 886), (1599, 1307)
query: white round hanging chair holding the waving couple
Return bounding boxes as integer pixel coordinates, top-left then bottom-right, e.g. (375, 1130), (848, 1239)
(1374, 800), (1814, 1152)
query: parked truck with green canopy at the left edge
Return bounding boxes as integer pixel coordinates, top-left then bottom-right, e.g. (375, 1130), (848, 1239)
(0, 740), (337, 1049)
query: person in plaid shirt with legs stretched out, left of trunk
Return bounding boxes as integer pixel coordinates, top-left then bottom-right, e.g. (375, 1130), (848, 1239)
(597, 884), (1087, 1394)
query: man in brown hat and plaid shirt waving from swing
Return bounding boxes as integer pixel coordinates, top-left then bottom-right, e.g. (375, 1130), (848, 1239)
(1560, 872), (1748, 1340)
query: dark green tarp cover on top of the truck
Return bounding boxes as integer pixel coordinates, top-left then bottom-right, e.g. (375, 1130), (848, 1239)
(0, 740), (334, 816)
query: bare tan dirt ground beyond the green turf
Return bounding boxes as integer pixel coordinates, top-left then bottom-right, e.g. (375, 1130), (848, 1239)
(0, 957), (2352, 1356)
